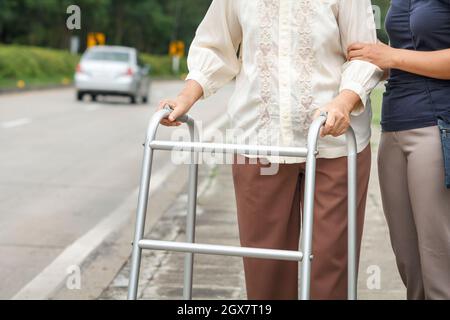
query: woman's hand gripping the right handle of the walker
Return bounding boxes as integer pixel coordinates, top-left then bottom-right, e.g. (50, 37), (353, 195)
(317, 90), (361, 138)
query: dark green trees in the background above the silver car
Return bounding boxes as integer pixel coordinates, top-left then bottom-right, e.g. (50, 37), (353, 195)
(0, 0), (211, 54)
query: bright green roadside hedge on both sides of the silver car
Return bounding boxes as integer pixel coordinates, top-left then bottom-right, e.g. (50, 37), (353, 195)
(0, 44), (187, 89)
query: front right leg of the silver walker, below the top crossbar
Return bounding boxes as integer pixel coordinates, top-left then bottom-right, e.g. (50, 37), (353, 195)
(300, 152), (316, 300)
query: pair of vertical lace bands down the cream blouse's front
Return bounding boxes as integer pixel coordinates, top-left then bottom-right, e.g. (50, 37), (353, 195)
(256, 0), (316, 145)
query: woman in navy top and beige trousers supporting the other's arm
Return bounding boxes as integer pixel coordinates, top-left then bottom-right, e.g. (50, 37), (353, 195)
(349, 0), (450, 300)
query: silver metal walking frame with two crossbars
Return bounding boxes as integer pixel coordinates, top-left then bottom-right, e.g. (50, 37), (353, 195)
(128, 107), (357, 300)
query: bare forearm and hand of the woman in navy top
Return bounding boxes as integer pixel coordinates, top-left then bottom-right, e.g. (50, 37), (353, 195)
(348, 43), (450, 80)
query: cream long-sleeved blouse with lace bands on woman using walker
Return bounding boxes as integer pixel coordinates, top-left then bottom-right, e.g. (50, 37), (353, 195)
(187, 0), (383, 163)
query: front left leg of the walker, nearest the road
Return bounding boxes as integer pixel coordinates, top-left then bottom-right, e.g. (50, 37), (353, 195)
(128, 144), (153, 300)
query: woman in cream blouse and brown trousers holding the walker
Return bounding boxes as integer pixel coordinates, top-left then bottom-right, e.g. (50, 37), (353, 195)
(160, 0), (383, 299)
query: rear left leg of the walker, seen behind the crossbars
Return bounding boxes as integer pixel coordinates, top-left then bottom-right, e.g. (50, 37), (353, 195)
(183, 125), (198, 300)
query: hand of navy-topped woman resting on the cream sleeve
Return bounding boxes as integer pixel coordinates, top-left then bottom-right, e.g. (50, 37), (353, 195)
(347, 42), (396, 70)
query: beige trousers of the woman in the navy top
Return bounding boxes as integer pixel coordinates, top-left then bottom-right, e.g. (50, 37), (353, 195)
(378, 127), (450, 299)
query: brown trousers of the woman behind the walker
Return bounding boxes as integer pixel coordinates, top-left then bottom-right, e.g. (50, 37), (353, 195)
(233, 147), (371, 300)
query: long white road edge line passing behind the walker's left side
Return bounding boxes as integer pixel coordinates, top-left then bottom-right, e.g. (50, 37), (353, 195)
(12, 111), (228, 300)
